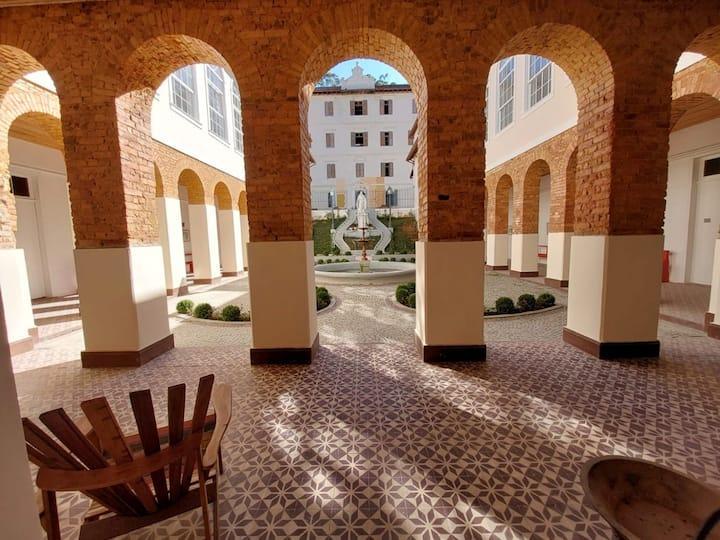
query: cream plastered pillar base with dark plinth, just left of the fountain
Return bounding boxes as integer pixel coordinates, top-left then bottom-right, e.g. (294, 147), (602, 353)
(248, 241), (318, 364)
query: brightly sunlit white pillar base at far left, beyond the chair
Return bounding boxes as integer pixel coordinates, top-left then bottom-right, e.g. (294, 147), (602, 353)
(0, 249), (37, 354)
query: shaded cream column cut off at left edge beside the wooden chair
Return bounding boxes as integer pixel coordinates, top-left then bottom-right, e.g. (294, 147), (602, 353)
(0, 292), (45, 539)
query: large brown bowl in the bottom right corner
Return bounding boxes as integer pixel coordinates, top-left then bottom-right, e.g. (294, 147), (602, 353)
(582, 456), (720, 540)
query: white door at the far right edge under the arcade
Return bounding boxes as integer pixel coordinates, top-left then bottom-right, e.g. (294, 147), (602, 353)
(690, 175), (720, 285)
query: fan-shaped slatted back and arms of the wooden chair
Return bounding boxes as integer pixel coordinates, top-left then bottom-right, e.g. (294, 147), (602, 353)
(23, 375), (219, 538)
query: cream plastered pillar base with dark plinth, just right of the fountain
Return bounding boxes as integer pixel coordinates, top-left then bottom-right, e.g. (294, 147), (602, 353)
(415, 241), (485, 362)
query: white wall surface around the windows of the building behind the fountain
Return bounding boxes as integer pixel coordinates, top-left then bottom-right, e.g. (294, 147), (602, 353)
(308, 90), (417, 204)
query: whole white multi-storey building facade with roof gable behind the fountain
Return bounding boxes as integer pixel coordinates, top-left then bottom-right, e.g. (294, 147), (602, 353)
(308, 65), (417, 210)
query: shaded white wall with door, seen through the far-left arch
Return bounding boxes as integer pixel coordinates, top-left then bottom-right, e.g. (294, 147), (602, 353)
(9, 138), (77, 297)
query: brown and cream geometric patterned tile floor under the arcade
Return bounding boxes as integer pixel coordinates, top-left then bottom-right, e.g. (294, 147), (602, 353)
(16, 280), (720, 539)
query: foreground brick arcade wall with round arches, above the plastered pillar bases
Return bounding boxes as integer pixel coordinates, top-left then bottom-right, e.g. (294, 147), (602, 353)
(0, 0), (720, 247)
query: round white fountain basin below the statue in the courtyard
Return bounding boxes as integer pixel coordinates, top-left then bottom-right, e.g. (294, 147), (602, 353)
(315, 261), (415, 285)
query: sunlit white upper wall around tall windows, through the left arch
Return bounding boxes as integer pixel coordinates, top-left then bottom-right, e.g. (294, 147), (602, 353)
(151, 64), (245, 180)
